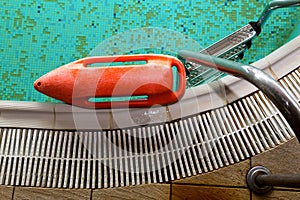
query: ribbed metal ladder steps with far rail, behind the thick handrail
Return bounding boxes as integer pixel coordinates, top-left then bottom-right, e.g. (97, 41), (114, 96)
(186, 0), (300, 87)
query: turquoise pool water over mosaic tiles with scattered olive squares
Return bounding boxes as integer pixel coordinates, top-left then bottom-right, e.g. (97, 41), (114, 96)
(0, 0), (300, 102)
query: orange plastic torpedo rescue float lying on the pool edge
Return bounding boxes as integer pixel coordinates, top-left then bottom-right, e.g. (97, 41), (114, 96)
(34, 54), (186, 108)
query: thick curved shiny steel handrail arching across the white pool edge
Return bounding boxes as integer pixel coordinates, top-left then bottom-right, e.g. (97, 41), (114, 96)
(178, 50), (300, 142)
